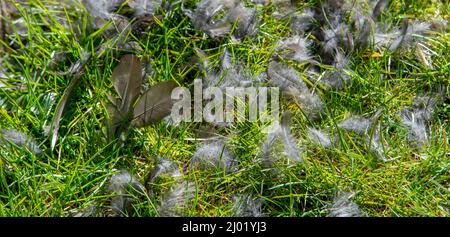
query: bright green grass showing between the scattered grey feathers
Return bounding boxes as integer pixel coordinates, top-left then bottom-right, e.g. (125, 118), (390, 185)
(0, 0), (450, 217)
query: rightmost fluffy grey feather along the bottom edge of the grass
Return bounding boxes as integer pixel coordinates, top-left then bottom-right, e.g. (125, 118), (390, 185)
(328, 192), (364, 217)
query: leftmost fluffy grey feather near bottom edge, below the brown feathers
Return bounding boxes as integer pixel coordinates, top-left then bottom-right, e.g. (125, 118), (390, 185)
(108, 171), (146, 216)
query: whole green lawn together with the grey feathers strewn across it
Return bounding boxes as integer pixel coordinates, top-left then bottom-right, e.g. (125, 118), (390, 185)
(0, 0), (450, 217)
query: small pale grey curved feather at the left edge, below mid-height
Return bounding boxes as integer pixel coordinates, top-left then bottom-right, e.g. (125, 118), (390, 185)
(0, 129), (42, 155)
